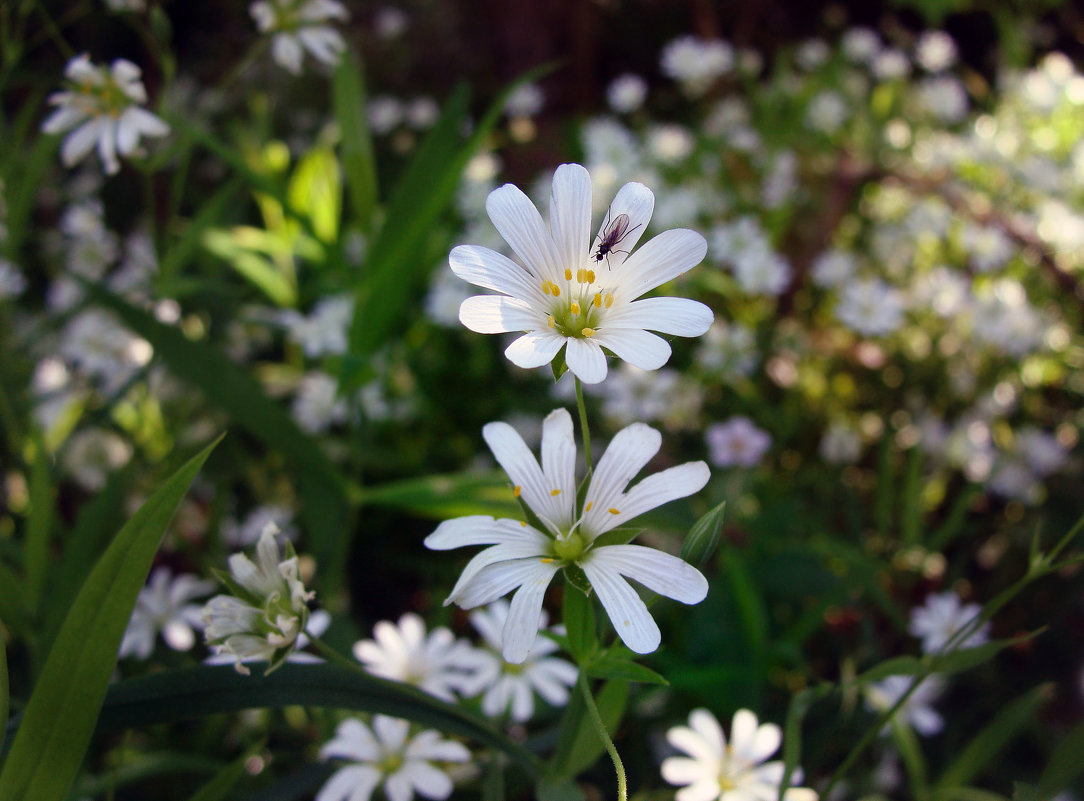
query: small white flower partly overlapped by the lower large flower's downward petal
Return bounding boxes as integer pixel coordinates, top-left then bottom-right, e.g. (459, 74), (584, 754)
(463, 598), (578, 723)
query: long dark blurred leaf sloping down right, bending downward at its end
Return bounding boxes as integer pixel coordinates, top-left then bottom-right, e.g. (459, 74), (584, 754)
(87, 285), (350, 595)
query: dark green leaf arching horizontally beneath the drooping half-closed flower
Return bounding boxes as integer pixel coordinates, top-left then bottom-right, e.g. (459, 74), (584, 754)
(99, 662), (538, 773)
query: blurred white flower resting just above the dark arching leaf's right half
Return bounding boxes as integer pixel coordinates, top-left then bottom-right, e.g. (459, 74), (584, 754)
(353, 612), (478, 702)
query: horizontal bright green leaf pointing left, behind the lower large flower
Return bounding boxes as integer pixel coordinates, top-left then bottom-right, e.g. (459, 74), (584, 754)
(354, 471), (519, 520)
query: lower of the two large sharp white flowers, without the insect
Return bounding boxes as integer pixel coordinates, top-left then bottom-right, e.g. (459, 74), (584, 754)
(425, 409), (709, 663)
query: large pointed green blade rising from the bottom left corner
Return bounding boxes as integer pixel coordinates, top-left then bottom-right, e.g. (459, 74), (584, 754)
(0, 440), (219, 801)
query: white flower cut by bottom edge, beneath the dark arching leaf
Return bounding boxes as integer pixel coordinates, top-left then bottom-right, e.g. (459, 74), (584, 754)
(315, 714), (470, 801)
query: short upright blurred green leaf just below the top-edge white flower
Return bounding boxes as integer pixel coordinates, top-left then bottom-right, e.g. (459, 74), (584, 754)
(332, 52), (377, 233)
